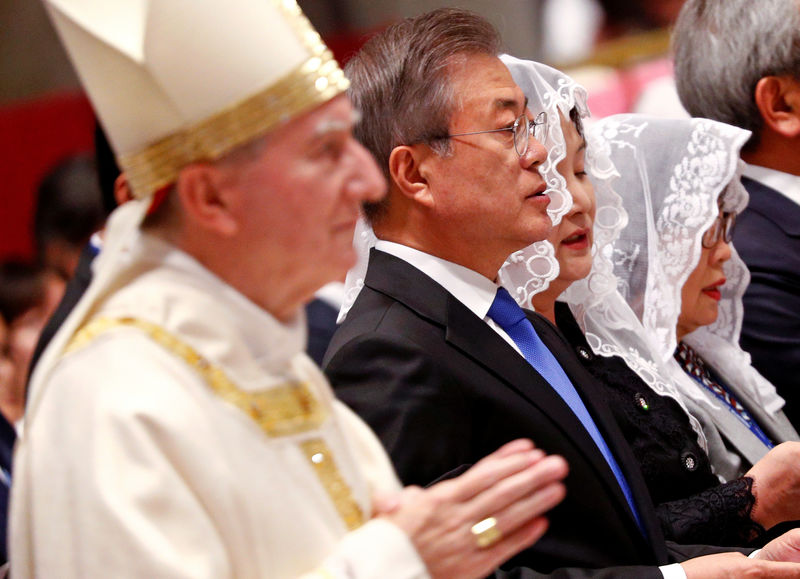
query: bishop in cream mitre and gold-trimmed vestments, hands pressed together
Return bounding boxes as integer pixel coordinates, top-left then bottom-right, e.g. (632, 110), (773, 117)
(9, 0), (567, 579)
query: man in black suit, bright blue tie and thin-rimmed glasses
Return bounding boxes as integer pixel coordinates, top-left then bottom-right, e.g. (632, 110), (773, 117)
(326, 9), (797, 578)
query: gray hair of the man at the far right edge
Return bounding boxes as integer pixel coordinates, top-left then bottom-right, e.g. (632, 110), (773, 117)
(672, 0), (800, 150)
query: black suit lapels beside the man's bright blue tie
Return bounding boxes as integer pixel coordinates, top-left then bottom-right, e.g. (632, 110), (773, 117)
(364, 250), (660, 537)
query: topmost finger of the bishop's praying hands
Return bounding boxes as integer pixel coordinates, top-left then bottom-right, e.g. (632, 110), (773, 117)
(438, 448), (545, 502)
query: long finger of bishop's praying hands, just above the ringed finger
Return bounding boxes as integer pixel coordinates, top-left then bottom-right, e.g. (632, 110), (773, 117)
(465, 455), (569, 521)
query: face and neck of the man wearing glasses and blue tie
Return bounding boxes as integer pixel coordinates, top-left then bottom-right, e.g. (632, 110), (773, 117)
(427, 55), (552, 278)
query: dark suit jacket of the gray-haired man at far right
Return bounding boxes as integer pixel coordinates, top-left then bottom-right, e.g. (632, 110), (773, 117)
(733, 177), (800, 429)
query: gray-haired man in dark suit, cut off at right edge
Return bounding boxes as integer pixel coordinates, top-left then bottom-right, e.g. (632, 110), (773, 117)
(673, 0), (800, 427)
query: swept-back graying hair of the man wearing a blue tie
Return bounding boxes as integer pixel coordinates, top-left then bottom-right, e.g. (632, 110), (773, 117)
(345, 8), (500, 223)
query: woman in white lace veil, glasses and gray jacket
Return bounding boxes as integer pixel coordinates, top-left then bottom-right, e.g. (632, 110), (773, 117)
(592, 116), (798, 479)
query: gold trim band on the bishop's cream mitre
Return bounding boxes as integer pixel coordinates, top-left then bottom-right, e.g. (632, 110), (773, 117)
(117, 0), (350, 198)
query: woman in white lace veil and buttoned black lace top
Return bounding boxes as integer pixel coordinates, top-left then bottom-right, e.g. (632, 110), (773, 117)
(501, 57), (797, 544)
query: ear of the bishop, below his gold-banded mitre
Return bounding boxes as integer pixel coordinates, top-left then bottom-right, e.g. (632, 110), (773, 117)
(177, 163), (239, 237)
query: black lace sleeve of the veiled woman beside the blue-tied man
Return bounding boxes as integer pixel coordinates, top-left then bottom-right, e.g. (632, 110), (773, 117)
(656, 477), (764, 546)
